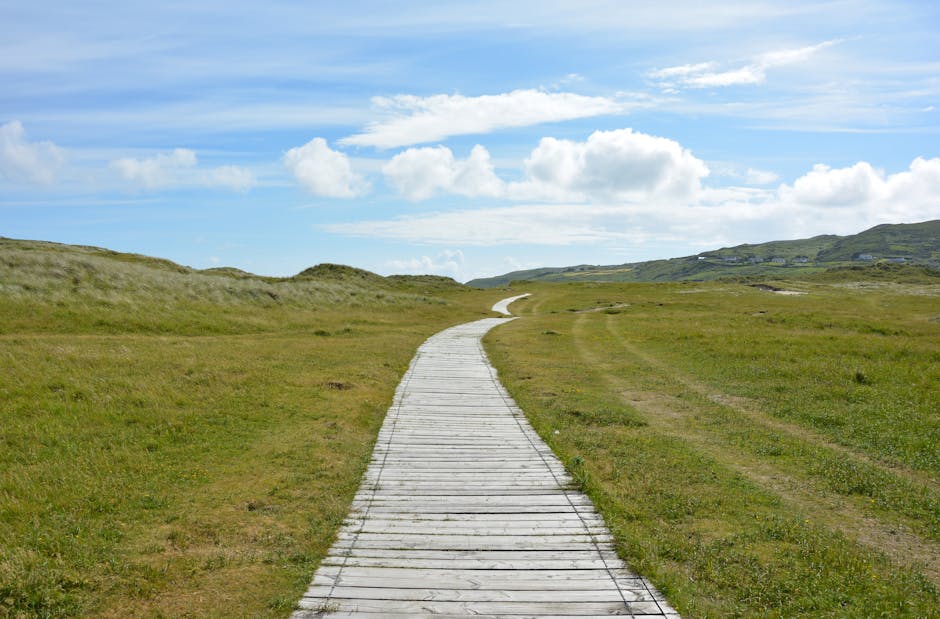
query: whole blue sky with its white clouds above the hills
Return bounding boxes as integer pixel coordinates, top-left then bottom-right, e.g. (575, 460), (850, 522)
(0, 0), (940, 281)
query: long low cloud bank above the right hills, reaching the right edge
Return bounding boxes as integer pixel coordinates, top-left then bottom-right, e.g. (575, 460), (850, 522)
(325, 158), (940, 253)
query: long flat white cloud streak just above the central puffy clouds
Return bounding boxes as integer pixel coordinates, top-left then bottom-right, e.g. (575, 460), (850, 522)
(340, 89), (627, 148)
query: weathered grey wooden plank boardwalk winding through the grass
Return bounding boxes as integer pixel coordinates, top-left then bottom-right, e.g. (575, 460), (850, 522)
(293, 297), (679, 619)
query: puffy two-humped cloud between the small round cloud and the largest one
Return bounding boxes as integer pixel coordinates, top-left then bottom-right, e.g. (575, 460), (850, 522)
(382, 144), (504, 200)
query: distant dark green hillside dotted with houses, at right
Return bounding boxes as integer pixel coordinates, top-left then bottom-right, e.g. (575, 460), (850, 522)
(467, 220), (940, 288)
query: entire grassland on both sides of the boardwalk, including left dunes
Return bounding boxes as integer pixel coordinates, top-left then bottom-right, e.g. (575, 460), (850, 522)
(0, 240), (940, 617)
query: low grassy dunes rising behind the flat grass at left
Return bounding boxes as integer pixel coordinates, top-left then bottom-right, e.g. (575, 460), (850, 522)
(0, 237), (470, 333)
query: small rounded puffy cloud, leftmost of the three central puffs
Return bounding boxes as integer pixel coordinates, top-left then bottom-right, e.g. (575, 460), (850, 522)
(284, 138), (369, 198)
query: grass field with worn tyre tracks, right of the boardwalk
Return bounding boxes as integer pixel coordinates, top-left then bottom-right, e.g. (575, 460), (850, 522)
(486, 271), (940, 617)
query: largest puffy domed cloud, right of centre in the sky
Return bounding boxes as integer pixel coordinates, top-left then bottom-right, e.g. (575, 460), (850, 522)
(511, 129), (708, 201)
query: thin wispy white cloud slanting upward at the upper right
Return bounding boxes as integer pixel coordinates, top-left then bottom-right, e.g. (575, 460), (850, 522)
(647, 40), (839, 89)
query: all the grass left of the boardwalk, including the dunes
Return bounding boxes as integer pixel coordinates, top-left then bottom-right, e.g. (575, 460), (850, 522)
(0, 240), (506, 617)
